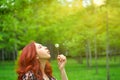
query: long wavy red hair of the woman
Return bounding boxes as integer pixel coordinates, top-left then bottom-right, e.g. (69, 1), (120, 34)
(17, 42), (52, 80)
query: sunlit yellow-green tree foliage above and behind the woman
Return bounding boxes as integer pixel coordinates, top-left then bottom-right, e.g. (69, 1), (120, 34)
(0, 0), (120, 56)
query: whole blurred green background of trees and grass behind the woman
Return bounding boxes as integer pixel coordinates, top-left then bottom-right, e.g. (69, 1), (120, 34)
(0, 0), (120, 80)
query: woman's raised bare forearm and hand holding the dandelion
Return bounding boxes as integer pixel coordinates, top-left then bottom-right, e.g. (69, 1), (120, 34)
(57, 55), (68, 80)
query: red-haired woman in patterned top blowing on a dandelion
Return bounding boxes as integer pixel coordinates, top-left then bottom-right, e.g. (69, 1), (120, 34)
(17, 42), (68, 80)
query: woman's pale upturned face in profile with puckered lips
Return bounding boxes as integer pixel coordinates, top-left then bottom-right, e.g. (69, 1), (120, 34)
(35, 43), (51, 59)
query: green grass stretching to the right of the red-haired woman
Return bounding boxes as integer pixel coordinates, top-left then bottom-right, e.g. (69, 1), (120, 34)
(52, 58), (120, 80)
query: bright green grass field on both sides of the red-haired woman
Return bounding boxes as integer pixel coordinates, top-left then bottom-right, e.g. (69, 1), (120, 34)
(0, 59), (120, 80)
